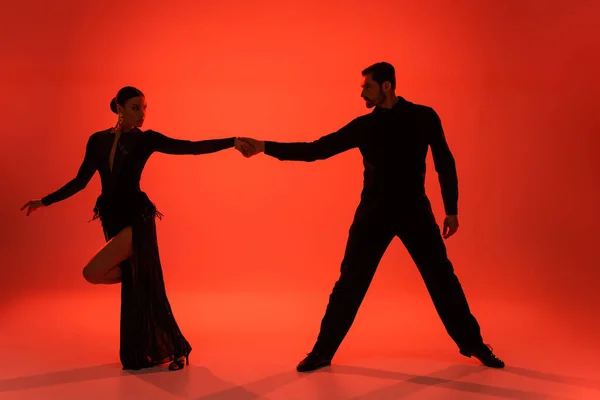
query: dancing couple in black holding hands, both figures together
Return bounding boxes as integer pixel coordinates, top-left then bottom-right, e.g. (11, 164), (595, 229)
(22, 62), (504, 372)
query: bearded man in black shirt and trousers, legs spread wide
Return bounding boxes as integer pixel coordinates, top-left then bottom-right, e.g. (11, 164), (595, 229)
(238, 62), (504, 372)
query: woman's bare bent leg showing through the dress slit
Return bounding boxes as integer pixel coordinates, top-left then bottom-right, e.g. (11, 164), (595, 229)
(83, 226), (133, 285)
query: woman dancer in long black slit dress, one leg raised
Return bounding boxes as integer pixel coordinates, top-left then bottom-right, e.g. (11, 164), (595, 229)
(21, 86), (248, 370)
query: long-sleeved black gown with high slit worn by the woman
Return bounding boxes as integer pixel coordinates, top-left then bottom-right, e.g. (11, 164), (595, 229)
(42, 129), (235, 370)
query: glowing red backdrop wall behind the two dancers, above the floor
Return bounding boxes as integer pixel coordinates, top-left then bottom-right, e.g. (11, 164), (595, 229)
(0, 0), (600, 342)
